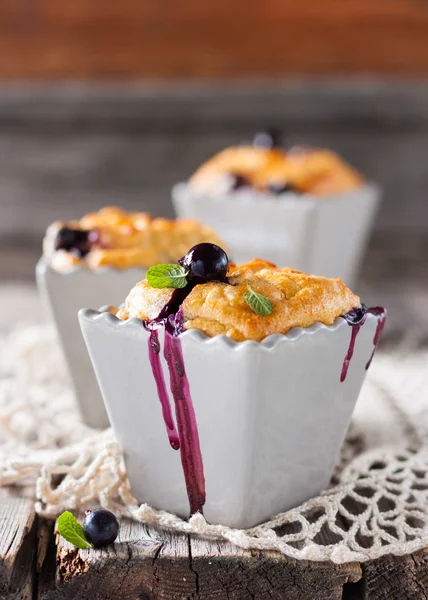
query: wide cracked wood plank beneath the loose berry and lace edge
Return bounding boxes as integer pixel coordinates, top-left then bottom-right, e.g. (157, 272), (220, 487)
(39, 520), (361, 600)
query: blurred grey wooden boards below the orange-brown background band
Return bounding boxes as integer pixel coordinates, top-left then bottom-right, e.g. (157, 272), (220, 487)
(0, 79), (428, 250)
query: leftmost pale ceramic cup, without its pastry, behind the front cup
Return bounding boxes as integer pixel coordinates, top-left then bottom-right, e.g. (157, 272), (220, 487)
(36, 258), (146, 429)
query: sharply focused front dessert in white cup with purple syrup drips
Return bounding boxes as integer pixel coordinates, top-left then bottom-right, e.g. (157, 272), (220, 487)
(79, 244), (385, 528)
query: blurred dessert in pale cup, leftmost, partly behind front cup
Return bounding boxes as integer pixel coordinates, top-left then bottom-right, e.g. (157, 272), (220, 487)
(36, 207), (224, 428)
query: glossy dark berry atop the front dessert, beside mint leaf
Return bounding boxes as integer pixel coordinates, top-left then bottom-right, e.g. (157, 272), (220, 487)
(178, 243), (229, 284)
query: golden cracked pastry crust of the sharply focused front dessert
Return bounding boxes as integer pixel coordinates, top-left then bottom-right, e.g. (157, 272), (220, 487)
(117, 259), (361, 342)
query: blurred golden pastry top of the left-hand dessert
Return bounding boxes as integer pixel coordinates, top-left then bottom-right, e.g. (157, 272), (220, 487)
(43, 207), (221, 272)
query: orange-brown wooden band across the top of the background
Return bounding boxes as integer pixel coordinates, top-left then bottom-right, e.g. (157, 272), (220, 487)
(0, 0), (428, 80)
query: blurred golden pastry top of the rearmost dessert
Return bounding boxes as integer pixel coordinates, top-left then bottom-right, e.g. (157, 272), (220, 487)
(189, 146), (363, 196)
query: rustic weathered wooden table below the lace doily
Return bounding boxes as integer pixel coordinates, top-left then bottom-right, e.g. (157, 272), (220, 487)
(0, 488), (428, 600)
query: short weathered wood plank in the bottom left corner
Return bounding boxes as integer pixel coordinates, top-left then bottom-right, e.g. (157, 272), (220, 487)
(0, 488), (37, 600)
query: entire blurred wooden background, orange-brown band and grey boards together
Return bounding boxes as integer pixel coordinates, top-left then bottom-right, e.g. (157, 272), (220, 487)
(0, 0), (428, 278)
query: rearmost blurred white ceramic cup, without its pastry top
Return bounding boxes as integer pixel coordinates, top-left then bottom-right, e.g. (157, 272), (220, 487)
(172, 183), (380, 287)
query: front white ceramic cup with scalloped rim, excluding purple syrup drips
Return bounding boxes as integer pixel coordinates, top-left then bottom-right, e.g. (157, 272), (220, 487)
(79, 310), (378, 528)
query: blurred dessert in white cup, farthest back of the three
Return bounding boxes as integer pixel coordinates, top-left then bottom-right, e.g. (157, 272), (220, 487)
(172, 134), (380, 286)
